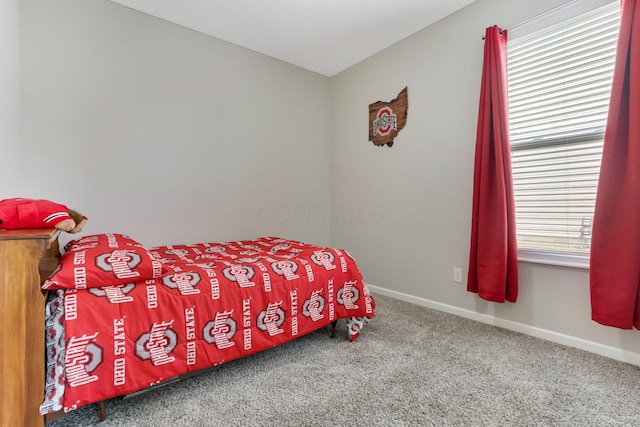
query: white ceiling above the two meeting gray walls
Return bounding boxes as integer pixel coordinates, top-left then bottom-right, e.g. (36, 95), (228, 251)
(111, 0), (475, 77)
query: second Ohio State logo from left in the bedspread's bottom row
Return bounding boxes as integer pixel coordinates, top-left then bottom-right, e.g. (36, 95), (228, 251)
(134, 320), (178, 366)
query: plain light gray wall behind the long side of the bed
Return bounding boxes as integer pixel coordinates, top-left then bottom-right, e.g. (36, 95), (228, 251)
(20, 0), (330, 249)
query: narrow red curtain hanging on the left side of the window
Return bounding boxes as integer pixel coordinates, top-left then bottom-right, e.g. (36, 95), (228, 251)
(467, 25), (518, 302)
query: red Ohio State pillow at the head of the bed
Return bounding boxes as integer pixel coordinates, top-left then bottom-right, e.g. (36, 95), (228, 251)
(42, 234), (163, 289)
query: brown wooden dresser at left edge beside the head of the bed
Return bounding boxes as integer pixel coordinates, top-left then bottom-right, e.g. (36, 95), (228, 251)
(0, 229), (59, 427)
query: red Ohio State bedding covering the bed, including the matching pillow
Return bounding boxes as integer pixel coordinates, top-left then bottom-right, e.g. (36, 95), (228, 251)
(40, 234), (375, 414)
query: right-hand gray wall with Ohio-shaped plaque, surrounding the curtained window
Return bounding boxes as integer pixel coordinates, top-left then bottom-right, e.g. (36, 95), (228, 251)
(331, 0), (640, 364)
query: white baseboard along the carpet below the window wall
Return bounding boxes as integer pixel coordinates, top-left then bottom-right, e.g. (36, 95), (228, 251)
(367, 283), (640, 366)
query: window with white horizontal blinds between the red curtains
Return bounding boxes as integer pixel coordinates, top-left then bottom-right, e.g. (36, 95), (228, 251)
(507, 0), (620, 266)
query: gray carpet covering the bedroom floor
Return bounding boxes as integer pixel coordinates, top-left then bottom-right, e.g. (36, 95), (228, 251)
(50, 295), (640, 427)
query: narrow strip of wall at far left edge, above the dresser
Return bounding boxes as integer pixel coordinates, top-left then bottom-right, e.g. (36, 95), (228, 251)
(0, 0), (21, 199)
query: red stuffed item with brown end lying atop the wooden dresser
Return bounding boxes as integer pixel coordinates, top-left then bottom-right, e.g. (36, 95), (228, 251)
(0, 198), (87, 233)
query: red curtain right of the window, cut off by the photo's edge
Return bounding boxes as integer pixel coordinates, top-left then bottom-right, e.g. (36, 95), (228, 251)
(590, 0), (640, 329)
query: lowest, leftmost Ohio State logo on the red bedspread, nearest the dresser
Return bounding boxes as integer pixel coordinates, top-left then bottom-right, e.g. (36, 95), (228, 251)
(65, 332), (103, 387)
